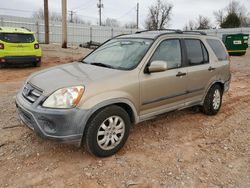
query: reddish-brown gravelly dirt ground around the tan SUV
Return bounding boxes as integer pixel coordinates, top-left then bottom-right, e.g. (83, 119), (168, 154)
(0, 45), (250, 188)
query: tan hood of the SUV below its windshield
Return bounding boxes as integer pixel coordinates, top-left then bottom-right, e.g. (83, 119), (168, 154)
(28, 62), (124, 95)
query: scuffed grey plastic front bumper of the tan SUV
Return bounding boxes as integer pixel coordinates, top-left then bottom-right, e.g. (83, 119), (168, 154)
(16, 92), (90, 146)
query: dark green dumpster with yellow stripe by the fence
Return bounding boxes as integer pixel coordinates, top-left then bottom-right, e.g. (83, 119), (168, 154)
(222, 33), (249, 56)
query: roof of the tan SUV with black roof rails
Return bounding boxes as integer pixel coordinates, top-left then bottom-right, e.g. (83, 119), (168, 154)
(118, 30), (211, 39)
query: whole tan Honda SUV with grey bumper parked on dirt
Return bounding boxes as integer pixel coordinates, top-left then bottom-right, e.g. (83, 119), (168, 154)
(16, 30), (231, 157)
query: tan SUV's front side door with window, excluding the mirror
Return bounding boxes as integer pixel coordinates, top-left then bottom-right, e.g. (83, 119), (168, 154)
(139, 39), (187, 116)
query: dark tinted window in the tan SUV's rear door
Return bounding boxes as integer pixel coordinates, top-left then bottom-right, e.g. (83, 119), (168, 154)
(185, 39), (209, 65)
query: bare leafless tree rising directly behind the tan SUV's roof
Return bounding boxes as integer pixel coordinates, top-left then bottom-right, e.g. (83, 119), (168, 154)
(145, 0), (173, 30)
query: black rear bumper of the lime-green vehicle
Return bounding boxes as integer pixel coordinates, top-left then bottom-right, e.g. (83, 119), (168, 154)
(0, 56), (41, 64)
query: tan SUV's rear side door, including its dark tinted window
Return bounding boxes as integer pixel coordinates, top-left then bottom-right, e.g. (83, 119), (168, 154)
(184, 38), (217, 106)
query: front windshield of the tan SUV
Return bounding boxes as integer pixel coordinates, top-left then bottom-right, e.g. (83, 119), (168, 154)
(83, 39), (153, 70)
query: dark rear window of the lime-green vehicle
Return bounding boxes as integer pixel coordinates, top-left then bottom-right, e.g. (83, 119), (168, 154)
(0, 33), (35, 43)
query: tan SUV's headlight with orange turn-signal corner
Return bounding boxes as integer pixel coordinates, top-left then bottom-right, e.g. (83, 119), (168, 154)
(43, 86), (84, 109)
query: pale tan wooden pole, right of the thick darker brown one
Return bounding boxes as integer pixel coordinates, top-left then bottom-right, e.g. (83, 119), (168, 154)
(62, 0), (67, 48)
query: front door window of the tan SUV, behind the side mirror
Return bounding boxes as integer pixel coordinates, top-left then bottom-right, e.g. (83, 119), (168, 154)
(150, 39), (181, 69)
